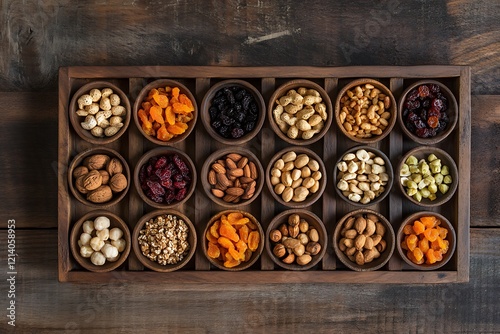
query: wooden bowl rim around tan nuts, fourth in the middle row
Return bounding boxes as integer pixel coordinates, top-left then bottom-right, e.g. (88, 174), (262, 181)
(266, 146), (327, 209)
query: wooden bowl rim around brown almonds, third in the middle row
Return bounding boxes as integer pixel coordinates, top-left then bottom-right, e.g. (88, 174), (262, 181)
(201, 146), (265, 208)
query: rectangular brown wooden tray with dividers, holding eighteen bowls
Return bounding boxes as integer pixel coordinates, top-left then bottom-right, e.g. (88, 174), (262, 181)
(58, 66), (471, 284)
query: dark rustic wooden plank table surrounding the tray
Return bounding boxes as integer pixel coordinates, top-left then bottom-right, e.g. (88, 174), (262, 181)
(0, 0), (500, 333)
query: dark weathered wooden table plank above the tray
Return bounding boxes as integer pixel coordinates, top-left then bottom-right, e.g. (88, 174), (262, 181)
(0, 0), (500, 94)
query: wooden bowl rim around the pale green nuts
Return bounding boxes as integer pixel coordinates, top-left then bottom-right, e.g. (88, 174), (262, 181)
(394, 146), (459, 208)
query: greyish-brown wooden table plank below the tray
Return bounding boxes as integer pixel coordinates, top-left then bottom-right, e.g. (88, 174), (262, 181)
(0, 228), (500, 333)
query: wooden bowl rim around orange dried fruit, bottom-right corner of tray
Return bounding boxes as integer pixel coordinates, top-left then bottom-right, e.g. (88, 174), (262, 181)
(396, 211), (457, 270)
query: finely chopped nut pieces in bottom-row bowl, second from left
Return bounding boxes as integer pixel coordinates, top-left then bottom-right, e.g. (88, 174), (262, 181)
(138, 215), (191, 266)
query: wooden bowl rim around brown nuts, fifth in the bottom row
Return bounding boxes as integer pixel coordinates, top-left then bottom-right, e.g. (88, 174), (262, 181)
(333, 209), (396, 271)
